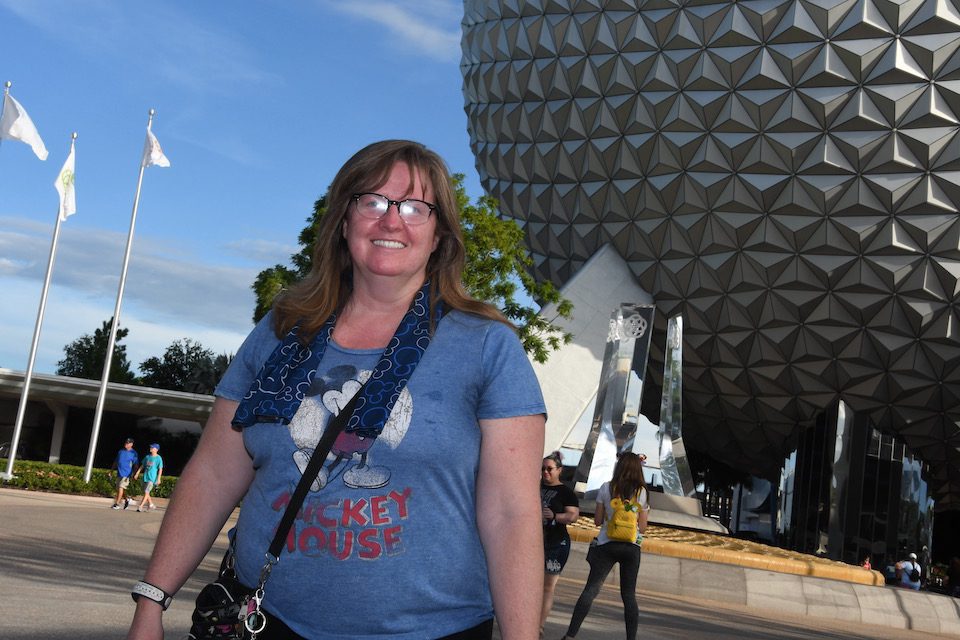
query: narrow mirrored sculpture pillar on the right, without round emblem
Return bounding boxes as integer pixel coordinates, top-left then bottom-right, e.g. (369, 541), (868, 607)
(659, 316), (697, 498)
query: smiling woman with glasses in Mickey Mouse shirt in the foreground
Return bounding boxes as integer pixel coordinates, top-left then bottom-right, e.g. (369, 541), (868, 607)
(128, 140), (544, 640)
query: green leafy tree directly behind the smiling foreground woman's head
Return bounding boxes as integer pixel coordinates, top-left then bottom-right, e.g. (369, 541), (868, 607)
(252, 173), (573, 362)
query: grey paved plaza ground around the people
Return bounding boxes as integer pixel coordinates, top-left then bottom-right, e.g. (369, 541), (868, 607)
(0, 489), (957, 640)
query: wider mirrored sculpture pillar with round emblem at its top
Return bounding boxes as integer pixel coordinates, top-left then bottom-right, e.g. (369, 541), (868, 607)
(574, 303), (654, 498)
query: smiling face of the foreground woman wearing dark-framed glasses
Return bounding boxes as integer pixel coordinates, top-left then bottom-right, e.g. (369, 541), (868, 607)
(343, 162), (439, 287)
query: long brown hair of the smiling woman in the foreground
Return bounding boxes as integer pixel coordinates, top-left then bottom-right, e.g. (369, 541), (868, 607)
(273, 140), (513, 342)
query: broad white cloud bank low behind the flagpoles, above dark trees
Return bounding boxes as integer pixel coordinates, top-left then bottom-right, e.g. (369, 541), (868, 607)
(0, 217), (266, 372)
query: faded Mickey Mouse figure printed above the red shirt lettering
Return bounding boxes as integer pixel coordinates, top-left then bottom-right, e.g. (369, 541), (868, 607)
(290, 365), (413, 492)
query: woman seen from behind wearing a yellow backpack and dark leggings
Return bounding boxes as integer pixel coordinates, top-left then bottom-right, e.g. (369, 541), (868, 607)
(564, 453), (650, 640)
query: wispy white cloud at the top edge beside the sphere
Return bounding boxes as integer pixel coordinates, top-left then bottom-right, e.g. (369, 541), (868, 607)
(324, 0), (463, 62)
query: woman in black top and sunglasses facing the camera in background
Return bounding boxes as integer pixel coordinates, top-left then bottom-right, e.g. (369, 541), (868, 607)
(540, 451), (580, 635)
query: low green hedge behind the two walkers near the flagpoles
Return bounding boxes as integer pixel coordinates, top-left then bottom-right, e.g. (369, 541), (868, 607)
(0, 458), (177, 498)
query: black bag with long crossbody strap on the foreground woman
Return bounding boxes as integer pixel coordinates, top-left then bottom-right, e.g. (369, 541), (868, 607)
(186, 386), (363, 640)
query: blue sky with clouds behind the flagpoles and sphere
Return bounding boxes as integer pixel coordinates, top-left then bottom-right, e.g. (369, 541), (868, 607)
(0, 0), (482, 373)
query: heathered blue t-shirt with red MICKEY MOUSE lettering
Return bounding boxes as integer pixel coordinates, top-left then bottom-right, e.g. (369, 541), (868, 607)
(215, 311), (546, 639)
